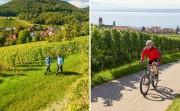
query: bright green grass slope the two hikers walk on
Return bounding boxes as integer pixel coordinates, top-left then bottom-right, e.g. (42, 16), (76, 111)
(0, 54), (88, 111)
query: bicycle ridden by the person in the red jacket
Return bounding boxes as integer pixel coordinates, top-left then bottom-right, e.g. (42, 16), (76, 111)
(140, 63), (159, 95)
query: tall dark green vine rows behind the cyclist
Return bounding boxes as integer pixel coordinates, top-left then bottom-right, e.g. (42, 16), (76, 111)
(91, 26), (180, 73)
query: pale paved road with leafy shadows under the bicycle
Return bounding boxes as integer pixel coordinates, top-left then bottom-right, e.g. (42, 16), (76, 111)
(91, 61), (180, 111)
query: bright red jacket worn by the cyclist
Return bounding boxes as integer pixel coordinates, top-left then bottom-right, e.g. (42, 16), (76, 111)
(141, 47), (161, 62)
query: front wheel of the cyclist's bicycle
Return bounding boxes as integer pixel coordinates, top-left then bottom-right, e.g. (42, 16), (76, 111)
(140, 74), (150, 95)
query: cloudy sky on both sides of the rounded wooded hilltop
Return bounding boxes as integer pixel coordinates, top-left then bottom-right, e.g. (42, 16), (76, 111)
(0, 0), (89, 8)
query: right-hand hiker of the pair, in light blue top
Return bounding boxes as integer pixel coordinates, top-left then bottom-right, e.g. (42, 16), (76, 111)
(55, 54), (64, 76)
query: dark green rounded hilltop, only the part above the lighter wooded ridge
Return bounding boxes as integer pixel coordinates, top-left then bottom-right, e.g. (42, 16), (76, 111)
(0, 0), (79, 16)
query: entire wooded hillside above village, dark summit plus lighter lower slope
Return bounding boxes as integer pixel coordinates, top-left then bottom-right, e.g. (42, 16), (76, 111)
(0, 0), (89, 25)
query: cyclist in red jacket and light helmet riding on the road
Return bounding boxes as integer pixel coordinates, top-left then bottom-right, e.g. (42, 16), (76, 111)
(140, 40), (161, 78)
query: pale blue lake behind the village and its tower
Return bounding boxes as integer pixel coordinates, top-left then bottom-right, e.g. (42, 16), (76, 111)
(91, 11), (180, 29)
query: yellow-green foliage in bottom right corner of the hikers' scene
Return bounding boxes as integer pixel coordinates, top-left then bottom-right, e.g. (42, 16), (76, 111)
(61, 76), (89, 111)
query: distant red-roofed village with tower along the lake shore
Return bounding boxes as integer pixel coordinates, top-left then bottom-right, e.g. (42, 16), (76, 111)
(98, 17), (180, 34)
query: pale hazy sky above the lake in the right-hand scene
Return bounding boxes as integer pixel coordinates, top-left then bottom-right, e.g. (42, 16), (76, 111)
(91, 0), (180, 10)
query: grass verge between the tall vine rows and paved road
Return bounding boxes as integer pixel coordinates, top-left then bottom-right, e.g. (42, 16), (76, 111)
(91, 53), (180, 87)
